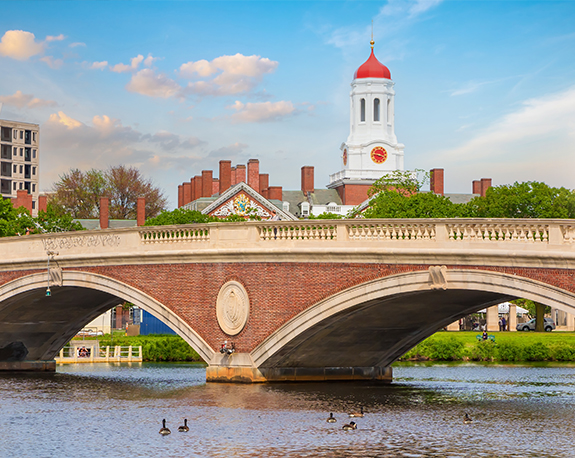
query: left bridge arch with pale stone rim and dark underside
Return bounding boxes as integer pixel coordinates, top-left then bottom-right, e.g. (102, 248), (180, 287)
(0, 270), (215, 361)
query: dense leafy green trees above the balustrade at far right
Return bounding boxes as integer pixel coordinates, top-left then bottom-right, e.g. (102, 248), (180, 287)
(467, 181), (575, 218)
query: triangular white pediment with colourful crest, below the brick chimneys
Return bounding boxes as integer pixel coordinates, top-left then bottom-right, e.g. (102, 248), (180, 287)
(202, 182), (297, 221)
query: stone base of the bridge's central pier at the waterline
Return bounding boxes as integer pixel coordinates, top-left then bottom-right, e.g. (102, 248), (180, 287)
(206, 353), (393, 383)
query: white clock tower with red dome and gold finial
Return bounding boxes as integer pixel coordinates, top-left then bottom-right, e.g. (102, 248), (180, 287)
(327, 40), (404, 205)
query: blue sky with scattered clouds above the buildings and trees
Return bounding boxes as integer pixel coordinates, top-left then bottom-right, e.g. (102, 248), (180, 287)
(0, 0), (575, 208)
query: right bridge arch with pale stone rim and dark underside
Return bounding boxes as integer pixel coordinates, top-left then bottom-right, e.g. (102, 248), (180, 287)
(251, 269), (575, 368)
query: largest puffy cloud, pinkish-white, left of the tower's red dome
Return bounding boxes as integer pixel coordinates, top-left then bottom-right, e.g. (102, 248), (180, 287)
(180, 53), (278, 96)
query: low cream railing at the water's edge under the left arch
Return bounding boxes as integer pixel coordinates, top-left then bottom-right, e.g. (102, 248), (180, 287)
(54, 345), (143, 364)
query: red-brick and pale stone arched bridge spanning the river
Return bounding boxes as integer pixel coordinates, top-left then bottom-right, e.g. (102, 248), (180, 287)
(0, 219), (575, 382)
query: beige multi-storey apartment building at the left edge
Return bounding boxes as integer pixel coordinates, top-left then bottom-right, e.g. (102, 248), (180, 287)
(0, 119), (40, 215)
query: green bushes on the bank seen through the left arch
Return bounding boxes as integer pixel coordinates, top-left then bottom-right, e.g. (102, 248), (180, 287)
(94, 334), (202, 362)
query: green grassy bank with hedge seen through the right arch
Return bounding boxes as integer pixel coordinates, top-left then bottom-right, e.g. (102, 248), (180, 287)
(400, 331), (575, 362)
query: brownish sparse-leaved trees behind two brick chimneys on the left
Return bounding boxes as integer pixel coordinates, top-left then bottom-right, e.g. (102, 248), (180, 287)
(50, 165), (167, 219)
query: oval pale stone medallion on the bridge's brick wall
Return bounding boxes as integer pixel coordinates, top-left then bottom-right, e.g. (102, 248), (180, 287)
(216, 281), (250, 336)
